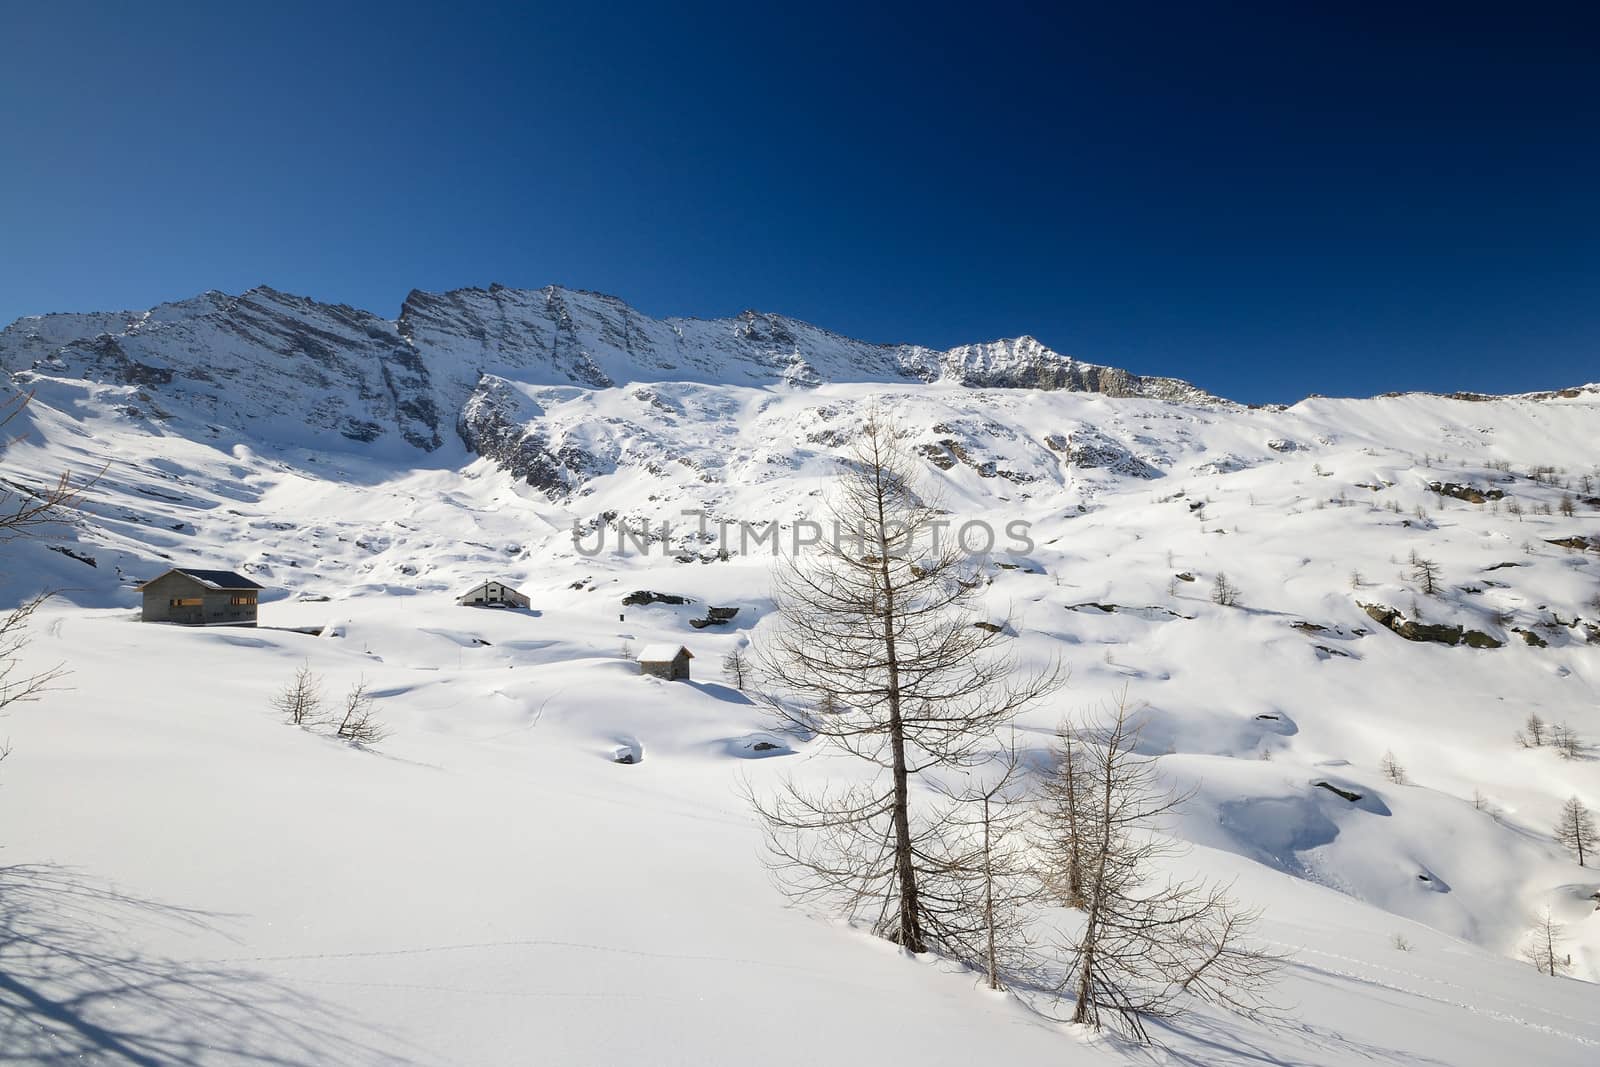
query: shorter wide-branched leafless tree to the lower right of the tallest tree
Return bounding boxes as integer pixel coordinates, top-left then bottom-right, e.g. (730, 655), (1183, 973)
(1070, 694), (1280, 1041)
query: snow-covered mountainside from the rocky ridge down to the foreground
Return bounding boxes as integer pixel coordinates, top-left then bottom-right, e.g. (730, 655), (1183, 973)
(0, 290), (1600, 1064)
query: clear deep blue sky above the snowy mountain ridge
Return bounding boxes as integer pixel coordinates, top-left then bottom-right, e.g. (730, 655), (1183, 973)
(0, 0), (1600, 400)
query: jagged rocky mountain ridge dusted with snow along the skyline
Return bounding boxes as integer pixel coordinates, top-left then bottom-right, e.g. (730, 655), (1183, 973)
(0, 279), (1224, 467)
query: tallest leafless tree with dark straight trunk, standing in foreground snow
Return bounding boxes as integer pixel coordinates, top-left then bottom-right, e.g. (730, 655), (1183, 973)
(752, 414), (1062, 952)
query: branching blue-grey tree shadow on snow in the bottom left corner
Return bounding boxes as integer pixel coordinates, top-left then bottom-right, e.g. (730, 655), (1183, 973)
(0, 864), (411, 1067)
